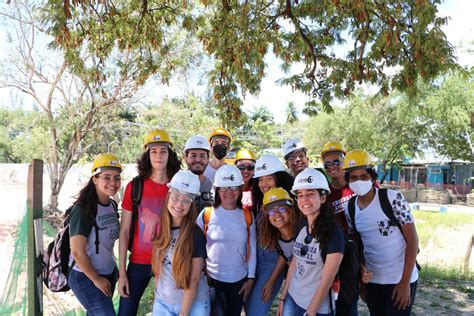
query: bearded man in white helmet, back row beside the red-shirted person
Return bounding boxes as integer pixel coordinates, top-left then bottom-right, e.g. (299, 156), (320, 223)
(184, 135), (214, 211)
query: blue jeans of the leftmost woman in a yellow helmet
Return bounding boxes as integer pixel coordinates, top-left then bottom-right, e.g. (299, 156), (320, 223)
(68, 269), (117, 316)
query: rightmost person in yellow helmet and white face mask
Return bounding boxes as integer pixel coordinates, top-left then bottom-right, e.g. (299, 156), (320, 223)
(344, 150), (418, 315)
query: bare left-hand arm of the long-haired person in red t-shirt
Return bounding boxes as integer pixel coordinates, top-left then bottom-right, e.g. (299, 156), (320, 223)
(118, 209), (132, 297)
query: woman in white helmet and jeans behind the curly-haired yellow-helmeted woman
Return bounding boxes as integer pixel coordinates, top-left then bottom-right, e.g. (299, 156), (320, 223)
(246, 154), (293, 315)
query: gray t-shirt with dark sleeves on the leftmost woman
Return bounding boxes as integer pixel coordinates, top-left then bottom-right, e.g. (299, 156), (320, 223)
(69, 203), (120, 275)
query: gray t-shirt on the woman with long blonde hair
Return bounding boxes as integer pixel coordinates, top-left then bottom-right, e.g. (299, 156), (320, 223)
(155, 225), (209, 305)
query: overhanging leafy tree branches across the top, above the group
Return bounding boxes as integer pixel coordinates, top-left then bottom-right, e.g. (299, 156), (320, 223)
(44, 0), (457, 124)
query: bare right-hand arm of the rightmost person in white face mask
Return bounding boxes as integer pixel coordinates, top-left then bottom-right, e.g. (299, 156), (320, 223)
(392, 223), (418, 309)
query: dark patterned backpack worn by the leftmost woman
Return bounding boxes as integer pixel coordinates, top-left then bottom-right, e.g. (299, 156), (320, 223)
(42, 199), (118, 292)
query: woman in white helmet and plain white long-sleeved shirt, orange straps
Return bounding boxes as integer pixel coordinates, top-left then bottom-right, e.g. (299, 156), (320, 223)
(197, 165), (257, 316)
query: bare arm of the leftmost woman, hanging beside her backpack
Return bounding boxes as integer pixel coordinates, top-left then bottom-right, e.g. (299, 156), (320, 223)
(69, 235), (112, 297)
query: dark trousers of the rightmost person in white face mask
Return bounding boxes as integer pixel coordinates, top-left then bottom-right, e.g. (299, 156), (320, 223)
(367, 281), (418, 316)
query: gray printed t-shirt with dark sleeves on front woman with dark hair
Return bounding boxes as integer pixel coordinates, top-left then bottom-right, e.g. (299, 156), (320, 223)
(288, 218), (344, 314)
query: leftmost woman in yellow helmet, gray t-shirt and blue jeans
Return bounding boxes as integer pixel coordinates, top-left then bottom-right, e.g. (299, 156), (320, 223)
(66, 153), (122, 315)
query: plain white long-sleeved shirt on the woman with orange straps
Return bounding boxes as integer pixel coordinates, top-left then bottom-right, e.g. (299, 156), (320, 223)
(196, 206), (257, 283)
